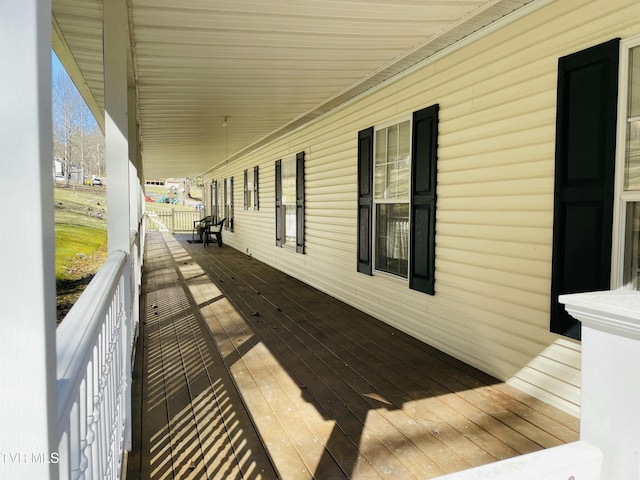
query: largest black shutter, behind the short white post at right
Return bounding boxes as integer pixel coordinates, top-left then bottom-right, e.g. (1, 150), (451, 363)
(551, 39), (620, 339)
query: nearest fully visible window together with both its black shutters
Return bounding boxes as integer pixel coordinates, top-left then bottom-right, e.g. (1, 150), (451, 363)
(356, 103), (440, 295)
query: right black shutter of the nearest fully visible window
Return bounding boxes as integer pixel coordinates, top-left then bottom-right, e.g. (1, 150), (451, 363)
(409, 104), (439, 295)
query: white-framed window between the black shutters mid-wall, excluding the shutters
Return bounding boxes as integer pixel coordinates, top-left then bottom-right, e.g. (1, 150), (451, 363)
(373, 119), (411, 278)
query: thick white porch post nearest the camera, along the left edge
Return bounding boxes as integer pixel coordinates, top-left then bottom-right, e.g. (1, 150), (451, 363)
(0, 0), (58, 480)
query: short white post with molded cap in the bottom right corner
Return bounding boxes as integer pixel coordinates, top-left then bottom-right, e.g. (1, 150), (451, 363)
(560, 290), (640, 480)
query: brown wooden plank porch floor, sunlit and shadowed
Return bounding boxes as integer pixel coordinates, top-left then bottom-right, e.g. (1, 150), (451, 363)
(127, 232), (579, 480)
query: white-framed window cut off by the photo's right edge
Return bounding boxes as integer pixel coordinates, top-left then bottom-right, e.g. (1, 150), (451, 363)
(611, 37), (640, 290)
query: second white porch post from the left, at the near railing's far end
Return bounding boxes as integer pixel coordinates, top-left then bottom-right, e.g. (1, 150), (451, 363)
(104, 0), (137, 450)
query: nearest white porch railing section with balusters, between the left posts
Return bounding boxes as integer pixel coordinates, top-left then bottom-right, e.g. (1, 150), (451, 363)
(57, 234), (144, 480)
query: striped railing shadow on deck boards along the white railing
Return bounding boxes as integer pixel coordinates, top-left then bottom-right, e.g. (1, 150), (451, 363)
(127, 234), (275, 480)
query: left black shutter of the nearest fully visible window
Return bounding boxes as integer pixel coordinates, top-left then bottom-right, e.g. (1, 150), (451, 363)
(357, 127), (374, 275)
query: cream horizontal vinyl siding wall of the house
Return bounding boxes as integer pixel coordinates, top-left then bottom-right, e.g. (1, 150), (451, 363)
(202, 0), (640, 415)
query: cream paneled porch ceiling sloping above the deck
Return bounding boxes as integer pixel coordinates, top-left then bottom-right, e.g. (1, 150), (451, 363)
(52, 0), (534, 178)
